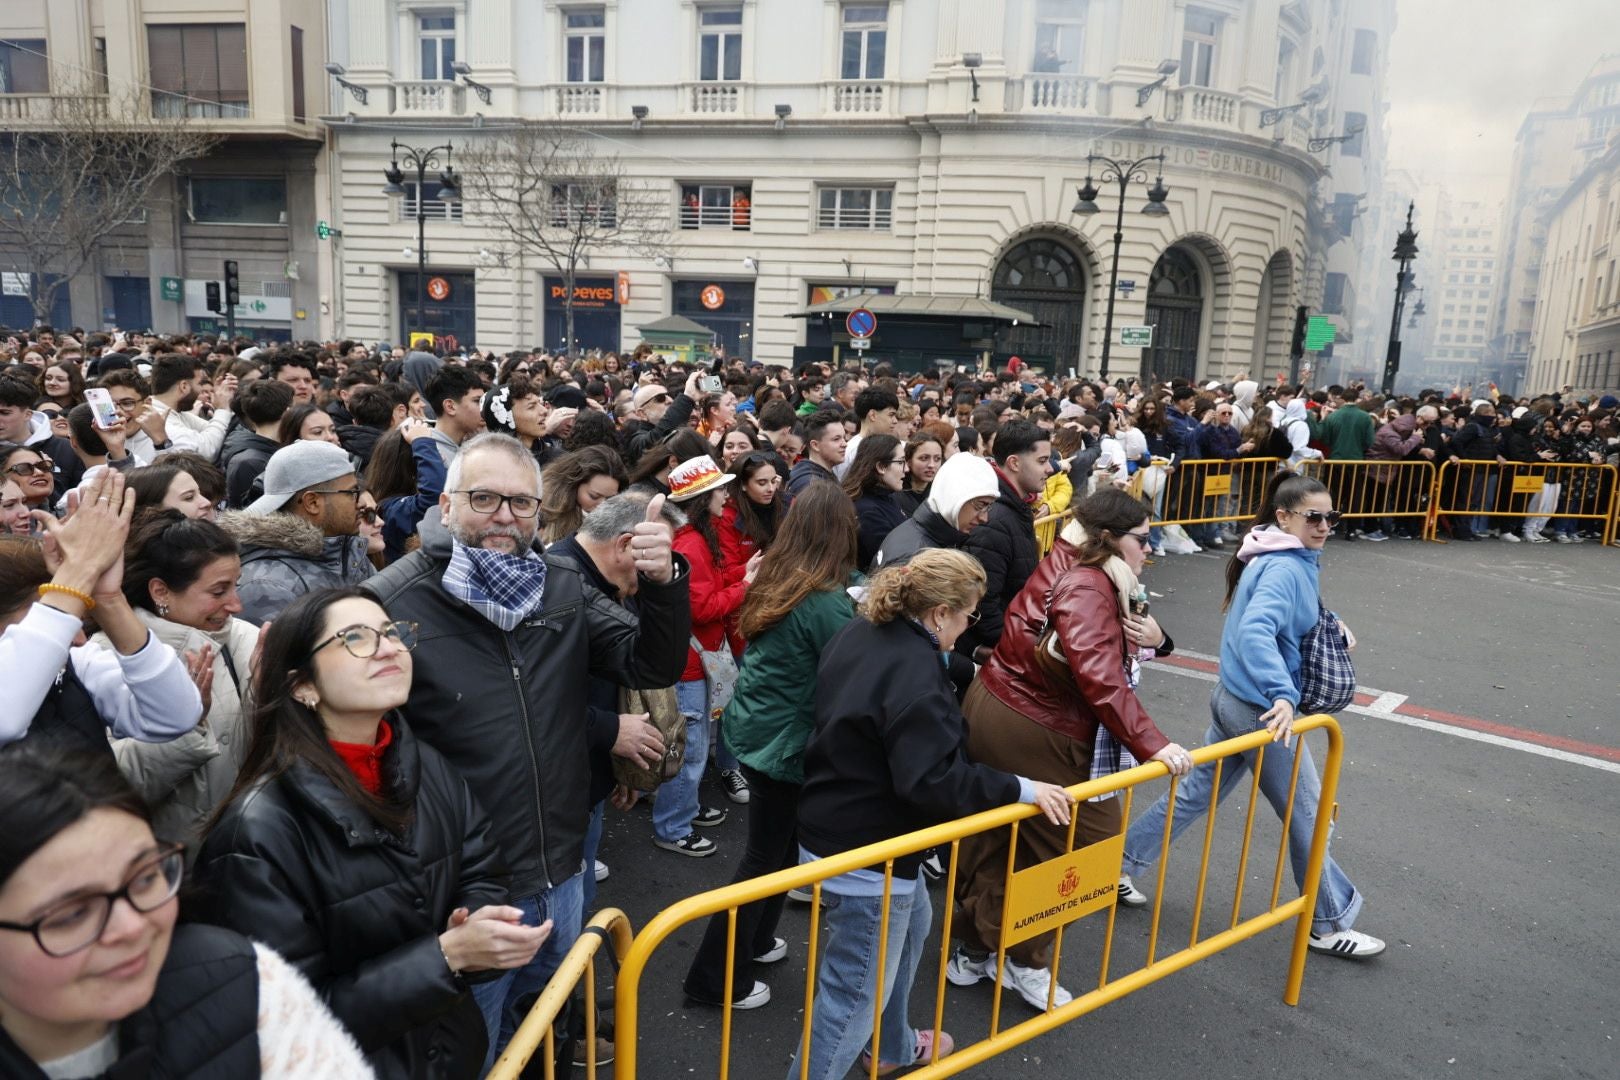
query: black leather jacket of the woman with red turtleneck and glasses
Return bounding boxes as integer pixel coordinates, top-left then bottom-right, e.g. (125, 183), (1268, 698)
(190, 716), (507, 1080)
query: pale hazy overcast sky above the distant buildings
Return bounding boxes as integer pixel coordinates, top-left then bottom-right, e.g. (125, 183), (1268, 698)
(1388, 0), (1620, 202)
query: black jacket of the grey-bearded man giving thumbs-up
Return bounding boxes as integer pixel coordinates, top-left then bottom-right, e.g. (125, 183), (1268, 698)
(365, 513), (692, 897)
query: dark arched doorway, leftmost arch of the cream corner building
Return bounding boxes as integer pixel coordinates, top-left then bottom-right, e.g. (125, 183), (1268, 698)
(990, 236), (1085, 372)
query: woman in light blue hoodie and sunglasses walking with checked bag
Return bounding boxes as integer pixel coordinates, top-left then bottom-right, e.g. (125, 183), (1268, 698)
(1124, 473), (1383, 960)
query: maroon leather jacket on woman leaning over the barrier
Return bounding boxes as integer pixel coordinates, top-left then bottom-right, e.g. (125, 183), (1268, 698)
(978, 539), (1170, 761)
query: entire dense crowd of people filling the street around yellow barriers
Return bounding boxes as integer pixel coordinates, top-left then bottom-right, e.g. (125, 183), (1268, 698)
(0, 327), (1620, 1078)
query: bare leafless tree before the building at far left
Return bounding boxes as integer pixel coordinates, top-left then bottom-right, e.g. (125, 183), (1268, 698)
(0, 79), (219, 322)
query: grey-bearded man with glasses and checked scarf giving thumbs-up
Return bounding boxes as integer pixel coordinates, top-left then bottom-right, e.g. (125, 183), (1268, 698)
(365, 432), (692, 1067)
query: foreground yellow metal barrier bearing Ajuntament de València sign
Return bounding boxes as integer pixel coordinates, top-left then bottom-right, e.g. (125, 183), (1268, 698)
(609, 716), (1343, 1080)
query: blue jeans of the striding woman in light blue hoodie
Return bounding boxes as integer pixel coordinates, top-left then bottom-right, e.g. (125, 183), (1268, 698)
(1123, 685), (1361, 934)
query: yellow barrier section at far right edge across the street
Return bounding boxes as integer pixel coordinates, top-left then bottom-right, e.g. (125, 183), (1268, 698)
(1427, 461), (1620, 544)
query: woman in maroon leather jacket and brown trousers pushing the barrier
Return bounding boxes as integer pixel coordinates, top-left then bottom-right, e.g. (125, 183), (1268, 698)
(946, 487), (1192, 1010)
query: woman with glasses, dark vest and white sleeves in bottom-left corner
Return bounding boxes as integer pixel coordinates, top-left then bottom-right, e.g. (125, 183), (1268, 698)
(0, 745), (373, 1080)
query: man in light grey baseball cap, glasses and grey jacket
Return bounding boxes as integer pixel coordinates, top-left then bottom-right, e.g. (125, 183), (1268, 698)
(219, 440), (373, 625)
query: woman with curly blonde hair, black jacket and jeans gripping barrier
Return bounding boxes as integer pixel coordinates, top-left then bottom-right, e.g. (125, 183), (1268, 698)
(787, 551), (1071, 1080)
